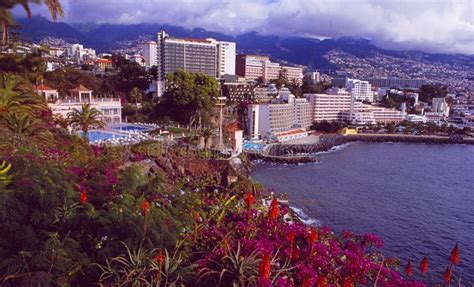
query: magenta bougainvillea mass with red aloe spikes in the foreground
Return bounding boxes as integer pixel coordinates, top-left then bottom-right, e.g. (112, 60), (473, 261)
(198, 194), (424, 286)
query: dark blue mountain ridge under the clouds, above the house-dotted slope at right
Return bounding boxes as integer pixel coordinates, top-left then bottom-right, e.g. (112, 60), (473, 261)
(18, 16), (474, 74)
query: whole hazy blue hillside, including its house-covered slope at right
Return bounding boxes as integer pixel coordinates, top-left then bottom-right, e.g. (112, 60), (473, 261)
(18, 16), (474, 93)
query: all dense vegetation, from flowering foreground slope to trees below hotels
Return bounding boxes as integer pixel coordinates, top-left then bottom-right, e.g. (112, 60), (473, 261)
(0, 3), (459, 286)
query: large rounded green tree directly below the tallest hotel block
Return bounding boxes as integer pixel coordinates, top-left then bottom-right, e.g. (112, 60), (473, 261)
(161, 71), (219, 129)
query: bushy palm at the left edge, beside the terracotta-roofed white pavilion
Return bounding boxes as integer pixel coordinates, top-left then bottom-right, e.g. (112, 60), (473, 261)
(0, 73), (47, 115)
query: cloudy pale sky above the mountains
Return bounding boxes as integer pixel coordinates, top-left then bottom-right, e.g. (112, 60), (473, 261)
(15, 0), (474, 54)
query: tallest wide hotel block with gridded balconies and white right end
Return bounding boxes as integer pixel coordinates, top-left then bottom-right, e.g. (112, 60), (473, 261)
(156, 31), (236, 80)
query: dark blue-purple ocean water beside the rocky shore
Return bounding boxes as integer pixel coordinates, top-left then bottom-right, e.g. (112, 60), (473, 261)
(252, 142), (474, 286)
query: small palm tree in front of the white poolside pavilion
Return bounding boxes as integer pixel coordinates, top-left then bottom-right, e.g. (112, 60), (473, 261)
(67, 104), (105, 137)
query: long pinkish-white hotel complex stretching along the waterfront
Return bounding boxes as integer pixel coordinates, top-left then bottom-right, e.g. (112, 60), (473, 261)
(248, 89), (406, 140)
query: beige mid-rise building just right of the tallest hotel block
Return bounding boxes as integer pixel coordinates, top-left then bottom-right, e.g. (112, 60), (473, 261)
(236, 54), (303, 83)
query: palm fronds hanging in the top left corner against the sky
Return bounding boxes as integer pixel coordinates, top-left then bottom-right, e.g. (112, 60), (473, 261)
(0, 0), (64, 45)
